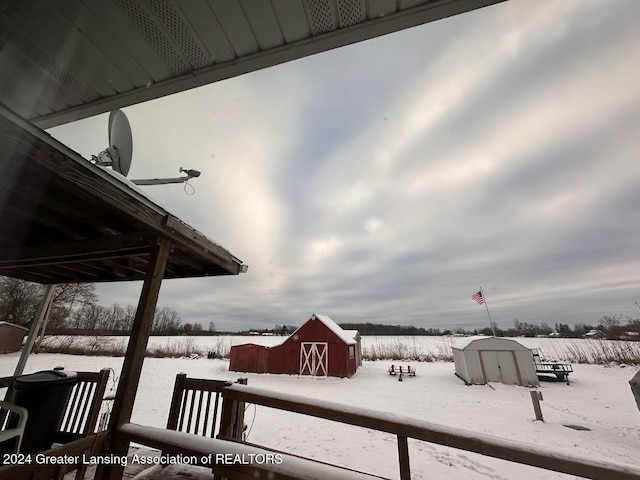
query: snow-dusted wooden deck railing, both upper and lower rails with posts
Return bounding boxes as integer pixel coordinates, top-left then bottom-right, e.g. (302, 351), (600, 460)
(5, 378), (640, 480)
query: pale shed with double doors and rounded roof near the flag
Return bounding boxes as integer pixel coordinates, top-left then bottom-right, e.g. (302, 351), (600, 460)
(452, 337), (539, 386)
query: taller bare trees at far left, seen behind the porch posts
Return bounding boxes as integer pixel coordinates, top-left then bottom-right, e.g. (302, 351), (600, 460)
(0, 277), (215, 335)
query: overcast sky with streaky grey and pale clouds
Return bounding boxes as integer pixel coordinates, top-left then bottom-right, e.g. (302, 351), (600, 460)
(50, 0), (640, 330)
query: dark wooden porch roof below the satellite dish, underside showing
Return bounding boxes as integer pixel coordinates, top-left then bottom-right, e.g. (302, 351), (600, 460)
(0, 105), (246, 284)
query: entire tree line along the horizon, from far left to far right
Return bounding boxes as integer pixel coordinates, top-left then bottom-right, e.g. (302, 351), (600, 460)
(5, 277), (640, 340)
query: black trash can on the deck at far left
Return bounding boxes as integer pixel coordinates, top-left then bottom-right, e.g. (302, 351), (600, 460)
(8, 369), (78, 453)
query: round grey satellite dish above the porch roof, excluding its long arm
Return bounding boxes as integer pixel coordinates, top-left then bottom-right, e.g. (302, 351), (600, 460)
(91, 110), (133, 177)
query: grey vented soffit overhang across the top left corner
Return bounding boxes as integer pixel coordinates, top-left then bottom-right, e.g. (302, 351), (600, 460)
(0, 0), (504, 128)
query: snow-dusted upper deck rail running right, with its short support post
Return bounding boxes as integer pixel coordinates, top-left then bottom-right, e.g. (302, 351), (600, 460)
(223, 384), (640, 480)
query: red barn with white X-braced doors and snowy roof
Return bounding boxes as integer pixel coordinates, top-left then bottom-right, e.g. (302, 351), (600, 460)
(229, 315), (362, 377)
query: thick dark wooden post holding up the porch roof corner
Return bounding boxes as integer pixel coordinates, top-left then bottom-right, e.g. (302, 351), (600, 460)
(96, 237), (171, 479)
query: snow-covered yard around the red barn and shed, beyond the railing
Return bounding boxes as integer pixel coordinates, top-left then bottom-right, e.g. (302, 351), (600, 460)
(0, 348), (640, 480)
